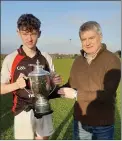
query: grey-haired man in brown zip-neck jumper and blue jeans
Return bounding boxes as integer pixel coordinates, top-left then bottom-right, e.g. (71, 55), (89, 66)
(58, 21), (121, 140)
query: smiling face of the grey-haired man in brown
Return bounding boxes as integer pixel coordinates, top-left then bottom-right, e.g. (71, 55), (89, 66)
(80, 30), (102, 54)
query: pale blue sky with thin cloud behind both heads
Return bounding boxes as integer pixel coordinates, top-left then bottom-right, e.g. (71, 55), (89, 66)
(1, 1), (121, 54)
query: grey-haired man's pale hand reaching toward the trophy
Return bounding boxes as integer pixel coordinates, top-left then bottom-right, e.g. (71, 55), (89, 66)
(58, 87), (76, 99)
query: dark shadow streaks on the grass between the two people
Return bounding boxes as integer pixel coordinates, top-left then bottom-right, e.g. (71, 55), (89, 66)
(50, 107), (74, 140)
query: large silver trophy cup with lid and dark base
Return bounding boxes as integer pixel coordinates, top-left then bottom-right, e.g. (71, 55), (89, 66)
(28, 60), (55, 118)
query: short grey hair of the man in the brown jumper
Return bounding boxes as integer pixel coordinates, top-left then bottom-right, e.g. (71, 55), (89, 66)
(79, 21), (102, 36)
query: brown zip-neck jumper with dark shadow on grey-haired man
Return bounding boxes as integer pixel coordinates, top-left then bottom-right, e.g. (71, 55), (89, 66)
(69, 44), (121, 126)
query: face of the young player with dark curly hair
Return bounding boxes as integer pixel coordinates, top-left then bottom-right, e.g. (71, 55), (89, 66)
(18, 30), (40, 49)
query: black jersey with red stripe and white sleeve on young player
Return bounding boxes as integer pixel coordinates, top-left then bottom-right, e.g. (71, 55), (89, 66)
(1, 46), (51, 115)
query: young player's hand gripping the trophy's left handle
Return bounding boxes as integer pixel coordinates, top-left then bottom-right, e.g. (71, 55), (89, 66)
(16, 73), (27, 89)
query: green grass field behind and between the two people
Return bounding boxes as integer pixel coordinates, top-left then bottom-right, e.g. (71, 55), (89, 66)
(0, 59), (121, 140)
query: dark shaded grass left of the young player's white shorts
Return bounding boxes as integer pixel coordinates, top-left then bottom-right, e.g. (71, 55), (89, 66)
(0, 94), (14, 139)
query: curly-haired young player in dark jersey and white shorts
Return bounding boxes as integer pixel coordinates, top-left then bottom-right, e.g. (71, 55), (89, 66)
(1, 14), (61, 139)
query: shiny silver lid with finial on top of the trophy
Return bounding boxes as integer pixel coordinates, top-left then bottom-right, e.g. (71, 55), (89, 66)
(28, 60), (50, 76)
